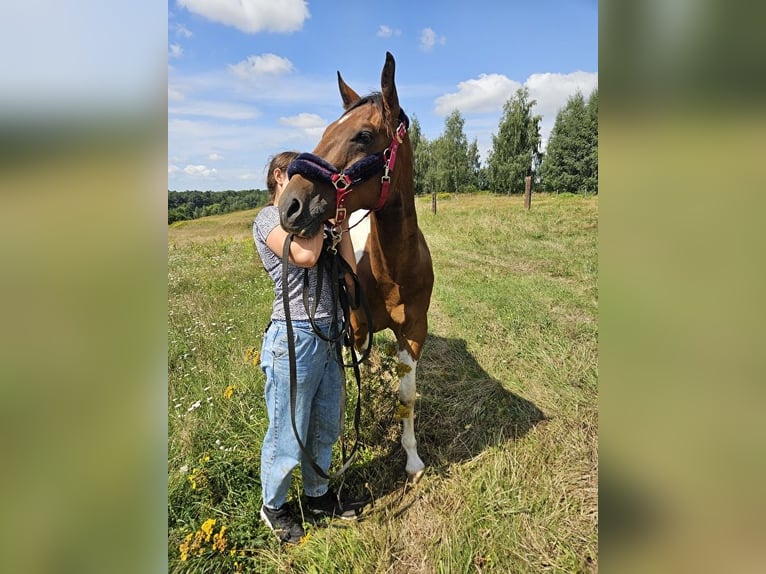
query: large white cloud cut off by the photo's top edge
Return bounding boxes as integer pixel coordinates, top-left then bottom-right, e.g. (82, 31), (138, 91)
(177, 0), (311, 34)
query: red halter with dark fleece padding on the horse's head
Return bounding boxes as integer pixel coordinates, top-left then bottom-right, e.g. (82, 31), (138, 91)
(287, 108), (410, 232)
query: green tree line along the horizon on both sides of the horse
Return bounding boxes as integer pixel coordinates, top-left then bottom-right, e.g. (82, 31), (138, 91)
(168, 88), (598, 223)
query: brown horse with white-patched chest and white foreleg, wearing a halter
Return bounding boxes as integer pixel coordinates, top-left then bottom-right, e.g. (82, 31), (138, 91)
(278, 52), (434, 483)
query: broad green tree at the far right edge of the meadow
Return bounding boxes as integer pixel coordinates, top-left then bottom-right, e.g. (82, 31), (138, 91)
(541, 90), (598, 193)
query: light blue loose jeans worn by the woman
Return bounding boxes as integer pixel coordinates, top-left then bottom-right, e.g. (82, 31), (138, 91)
(261, 319), (345, 508)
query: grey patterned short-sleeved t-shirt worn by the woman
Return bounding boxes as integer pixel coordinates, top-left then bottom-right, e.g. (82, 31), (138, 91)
(253, 205), (332, 320)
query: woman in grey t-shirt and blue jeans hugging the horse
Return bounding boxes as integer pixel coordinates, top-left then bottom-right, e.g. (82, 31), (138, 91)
(253, 152), (357, 544)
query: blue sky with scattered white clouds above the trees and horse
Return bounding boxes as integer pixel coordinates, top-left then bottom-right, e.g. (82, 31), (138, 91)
(168, 0), (598, 191)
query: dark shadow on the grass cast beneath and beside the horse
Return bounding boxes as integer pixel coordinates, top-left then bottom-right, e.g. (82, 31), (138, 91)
(334, 335), (546, 508)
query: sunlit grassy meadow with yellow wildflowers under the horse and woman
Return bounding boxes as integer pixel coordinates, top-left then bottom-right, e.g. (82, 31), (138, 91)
(168, 194), (598, 574)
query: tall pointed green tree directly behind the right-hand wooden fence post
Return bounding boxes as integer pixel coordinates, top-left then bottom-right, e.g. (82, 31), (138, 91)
(487, 88), (542, 193)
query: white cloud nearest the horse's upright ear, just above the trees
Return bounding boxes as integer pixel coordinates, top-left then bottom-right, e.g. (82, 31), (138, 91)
(435, 74), (521, 116)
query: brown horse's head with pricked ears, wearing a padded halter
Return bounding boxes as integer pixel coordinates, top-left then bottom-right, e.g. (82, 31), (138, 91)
(279, 52), (412, 237)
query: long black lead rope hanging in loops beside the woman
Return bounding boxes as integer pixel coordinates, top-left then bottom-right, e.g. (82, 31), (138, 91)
(282, 233), (373, 480)
